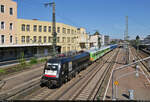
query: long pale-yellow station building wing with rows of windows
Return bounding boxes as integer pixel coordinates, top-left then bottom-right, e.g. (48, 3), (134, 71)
(17, 19), (86, 53)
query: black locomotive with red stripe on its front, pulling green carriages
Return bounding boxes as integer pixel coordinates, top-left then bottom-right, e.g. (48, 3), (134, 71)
(41, 52), (91, 88)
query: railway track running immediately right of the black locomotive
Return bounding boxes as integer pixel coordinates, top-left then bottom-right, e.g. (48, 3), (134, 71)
(20, 48), (118, 100)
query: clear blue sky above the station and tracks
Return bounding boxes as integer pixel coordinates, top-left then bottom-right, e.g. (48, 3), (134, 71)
(14, 0), (150, 39)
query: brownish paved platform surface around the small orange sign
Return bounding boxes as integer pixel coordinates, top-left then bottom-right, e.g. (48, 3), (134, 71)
(105, 48), (150, 100)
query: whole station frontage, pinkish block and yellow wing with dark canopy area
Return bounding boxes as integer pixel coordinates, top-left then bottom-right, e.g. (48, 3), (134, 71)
(0, 0), (88, 61)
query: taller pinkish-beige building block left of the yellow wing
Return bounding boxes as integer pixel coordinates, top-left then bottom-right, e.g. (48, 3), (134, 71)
(0, 0), (17, 45)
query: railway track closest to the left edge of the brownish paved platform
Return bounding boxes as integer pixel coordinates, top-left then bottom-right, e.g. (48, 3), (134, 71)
(70, 48), (117, 100)
